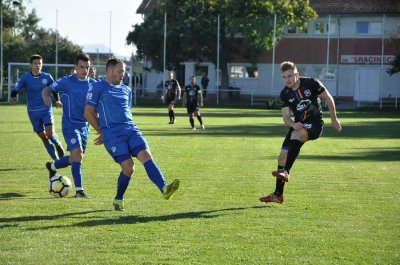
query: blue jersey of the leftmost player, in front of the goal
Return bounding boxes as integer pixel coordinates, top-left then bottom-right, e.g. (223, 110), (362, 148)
(14, 72), (54, 111)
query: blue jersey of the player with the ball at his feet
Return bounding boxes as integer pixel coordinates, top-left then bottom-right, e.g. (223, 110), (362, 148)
(49, 75), (96, 126)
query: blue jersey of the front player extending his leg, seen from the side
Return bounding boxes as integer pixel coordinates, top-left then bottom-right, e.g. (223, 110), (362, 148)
(86, 80), (135, 130)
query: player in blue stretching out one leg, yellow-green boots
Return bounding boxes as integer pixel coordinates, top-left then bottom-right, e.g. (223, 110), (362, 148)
(85, 58), (179, 211)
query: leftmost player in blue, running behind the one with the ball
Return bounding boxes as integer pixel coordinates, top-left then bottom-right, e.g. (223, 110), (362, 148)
(10, 54), (64, 160)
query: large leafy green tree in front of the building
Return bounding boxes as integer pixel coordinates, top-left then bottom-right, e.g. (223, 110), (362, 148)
(127, 0), (316, 88)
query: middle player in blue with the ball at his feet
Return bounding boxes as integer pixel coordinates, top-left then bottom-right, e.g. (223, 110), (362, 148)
(42, 53), (96, 198)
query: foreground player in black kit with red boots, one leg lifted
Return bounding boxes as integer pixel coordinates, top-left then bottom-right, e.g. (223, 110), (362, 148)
(260, 62), (342, 203)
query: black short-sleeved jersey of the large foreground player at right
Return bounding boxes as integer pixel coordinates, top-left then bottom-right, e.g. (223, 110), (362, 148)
(280, 77), (326, 123)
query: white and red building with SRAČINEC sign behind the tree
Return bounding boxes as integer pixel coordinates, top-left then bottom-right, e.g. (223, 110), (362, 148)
(137, 0), (400, 102)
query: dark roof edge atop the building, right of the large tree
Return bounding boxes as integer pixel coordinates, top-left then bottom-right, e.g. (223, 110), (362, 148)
(310, 0), (400, 15)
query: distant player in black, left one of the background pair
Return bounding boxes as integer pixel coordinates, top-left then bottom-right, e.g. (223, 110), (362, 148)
(161, 71), (181, 124)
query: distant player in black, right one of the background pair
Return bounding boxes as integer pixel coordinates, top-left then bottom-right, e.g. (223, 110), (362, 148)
(183, 76), (205, 130)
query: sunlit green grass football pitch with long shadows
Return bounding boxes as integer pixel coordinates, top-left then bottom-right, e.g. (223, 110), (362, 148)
(0, 105), (400, 264)
